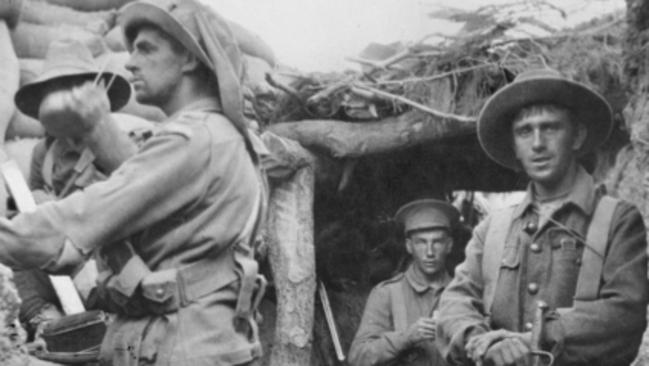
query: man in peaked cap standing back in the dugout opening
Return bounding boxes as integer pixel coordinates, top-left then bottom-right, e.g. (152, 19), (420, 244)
(349, 199), (459, 366)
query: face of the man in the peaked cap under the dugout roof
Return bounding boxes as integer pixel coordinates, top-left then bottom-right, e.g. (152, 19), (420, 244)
(406, 229), (453, 277)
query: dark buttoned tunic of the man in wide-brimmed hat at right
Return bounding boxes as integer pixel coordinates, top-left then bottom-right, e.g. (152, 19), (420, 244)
(437, 169), (649, 366)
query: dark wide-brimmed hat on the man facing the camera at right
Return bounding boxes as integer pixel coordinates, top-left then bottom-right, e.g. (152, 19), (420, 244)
(478, 68), (613, 170)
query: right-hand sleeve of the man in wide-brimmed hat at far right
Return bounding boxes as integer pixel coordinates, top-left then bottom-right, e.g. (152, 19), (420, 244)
(546, 203), (649, 365)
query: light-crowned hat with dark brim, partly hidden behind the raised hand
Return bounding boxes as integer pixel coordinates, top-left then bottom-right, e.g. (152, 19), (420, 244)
(14, 40), (131, 119)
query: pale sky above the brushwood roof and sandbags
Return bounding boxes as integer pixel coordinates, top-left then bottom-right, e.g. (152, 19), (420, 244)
(202, 0), (625, 72)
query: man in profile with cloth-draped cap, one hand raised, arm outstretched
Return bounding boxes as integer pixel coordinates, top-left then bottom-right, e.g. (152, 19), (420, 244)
(0, 0), (265, 366)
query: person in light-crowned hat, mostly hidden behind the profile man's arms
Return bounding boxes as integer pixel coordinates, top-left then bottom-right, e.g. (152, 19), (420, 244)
(15, 41), (140, 334)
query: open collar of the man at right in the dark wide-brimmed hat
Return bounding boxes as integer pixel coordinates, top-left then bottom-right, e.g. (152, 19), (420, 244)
(514, 165), (597, 218)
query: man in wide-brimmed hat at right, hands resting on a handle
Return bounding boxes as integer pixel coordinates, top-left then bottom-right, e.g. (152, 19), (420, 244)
(437, 69), (649, 366)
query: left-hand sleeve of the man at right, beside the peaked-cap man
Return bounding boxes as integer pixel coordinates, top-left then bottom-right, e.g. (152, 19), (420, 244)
(437, 218), (489, 365)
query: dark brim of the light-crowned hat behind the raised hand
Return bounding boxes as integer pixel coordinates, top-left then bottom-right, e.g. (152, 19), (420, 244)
(14, 72), (131, 119)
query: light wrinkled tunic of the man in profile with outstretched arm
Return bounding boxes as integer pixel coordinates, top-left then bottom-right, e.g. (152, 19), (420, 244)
(0, 99), (260, 366)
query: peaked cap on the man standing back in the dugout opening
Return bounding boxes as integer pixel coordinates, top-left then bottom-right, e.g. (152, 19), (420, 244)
(394, 198), (460, 235)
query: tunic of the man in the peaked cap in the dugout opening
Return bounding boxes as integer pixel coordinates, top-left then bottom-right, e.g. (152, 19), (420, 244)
(349, 265), (450, 366)
